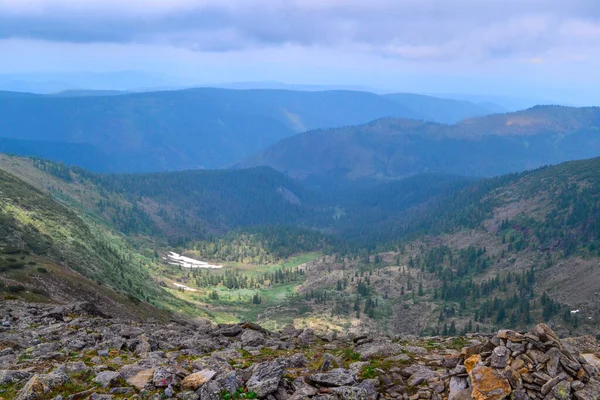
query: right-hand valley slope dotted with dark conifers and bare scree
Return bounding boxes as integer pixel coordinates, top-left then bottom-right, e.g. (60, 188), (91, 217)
(268, 158), (600, 335)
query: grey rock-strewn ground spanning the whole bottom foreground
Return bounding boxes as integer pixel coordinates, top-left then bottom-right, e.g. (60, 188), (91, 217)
(0, 301), (600, 400)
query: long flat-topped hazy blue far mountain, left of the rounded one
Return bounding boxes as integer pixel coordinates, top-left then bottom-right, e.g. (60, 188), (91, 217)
(0, 88), (418, 172)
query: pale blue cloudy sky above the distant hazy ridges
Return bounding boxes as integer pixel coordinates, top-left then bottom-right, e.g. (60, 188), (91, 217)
(0, 0), (600, 105)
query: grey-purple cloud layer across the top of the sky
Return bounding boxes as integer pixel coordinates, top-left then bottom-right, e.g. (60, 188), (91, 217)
(0, 0), (600, 61)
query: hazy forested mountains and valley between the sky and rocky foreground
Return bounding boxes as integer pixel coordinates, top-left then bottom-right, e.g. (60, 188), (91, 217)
(0, 89), (600, 335)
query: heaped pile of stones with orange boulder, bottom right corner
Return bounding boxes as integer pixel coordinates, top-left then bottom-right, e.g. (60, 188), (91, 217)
(450, 324), (600, 400)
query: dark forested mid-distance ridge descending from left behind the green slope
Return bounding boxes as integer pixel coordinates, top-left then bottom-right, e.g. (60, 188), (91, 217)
(0, 155), (332, 243)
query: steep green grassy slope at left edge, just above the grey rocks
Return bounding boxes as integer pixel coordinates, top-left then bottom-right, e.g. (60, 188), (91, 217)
(0, 166), (176, 318)
